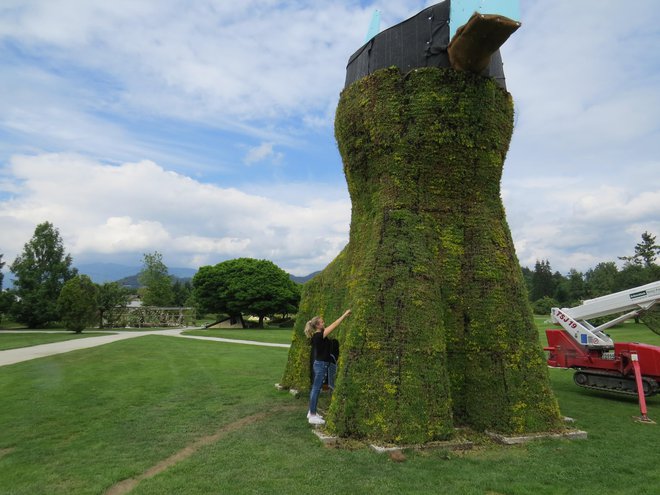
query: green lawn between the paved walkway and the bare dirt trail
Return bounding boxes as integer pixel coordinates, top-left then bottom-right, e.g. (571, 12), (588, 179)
(0, 335), (288, 494)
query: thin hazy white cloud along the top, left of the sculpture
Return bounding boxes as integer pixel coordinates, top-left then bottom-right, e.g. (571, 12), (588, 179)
(0, 0), (378, 125)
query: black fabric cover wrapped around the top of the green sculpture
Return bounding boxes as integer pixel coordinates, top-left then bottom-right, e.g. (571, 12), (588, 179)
(344, 0), (506, 89)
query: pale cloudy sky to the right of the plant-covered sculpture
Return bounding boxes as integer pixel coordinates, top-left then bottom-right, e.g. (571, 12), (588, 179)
(502, 0), (660, 273)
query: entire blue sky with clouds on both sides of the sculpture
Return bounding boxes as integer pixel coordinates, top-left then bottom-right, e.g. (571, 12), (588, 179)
(0, 0), (660, 275)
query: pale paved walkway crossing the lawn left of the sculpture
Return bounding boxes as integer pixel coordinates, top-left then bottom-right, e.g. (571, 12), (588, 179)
(0, 327), (289, 366)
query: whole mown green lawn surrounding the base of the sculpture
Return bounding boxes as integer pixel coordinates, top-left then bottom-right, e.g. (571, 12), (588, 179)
(0, 324), (660, 495)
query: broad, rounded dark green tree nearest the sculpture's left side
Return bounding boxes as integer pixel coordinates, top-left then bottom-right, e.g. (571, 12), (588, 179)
(193, 258), (300, 328)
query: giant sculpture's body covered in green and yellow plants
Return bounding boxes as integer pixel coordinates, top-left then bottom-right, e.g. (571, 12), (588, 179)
(282, 68), (560, 443)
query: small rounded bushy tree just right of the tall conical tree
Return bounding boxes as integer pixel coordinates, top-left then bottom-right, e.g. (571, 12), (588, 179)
(57, 275), (98, 333)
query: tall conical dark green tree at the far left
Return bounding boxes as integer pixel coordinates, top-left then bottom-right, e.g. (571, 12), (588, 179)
(11, 222), (77, 328)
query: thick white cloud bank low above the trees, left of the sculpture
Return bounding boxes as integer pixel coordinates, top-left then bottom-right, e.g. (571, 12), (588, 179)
(0, 154), (350, 275)
